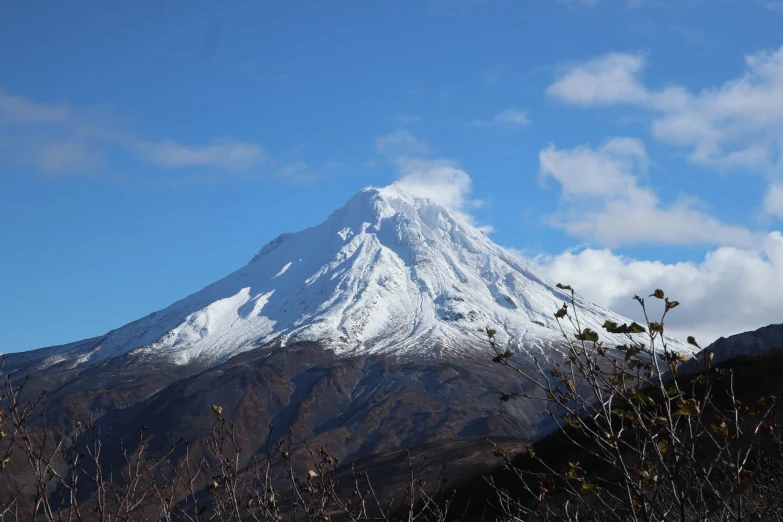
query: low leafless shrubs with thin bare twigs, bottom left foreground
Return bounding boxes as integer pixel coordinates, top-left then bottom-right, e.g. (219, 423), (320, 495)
(0, 360), (460, 522)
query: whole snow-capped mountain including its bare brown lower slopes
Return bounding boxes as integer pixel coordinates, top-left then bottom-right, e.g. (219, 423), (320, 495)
(4, 186), (708, 484)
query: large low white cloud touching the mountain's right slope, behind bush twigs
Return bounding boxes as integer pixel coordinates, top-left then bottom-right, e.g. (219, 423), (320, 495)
(531, 232), (783, 346)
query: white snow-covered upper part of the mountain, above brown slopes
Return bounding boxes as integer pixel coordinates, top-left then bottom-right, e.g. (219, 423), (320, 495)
(19, 185), (681, 366)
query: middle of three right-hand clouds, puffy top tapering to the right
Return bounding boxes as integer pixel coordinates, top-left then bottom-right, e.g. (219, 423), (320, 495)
(539, 138), (759, 247)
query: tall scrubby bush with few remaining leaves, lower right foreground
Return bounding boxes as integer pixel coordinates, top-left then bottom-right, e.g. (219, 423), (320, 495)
(487, 285), (783, 522)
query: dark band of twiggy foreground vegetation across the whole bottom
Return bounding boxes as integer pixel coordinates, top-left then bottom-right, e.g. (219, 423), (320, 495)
(0, 285), (783, 522)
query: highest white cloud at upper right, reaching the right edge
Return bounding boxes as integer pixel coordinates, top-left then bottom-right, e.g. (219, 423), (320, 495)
(547, 47), (783, 172)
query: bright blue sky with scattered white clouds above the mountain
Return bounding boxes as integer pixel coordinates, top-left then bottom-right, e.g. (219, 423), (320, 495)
(0, 0), (783, 351)
